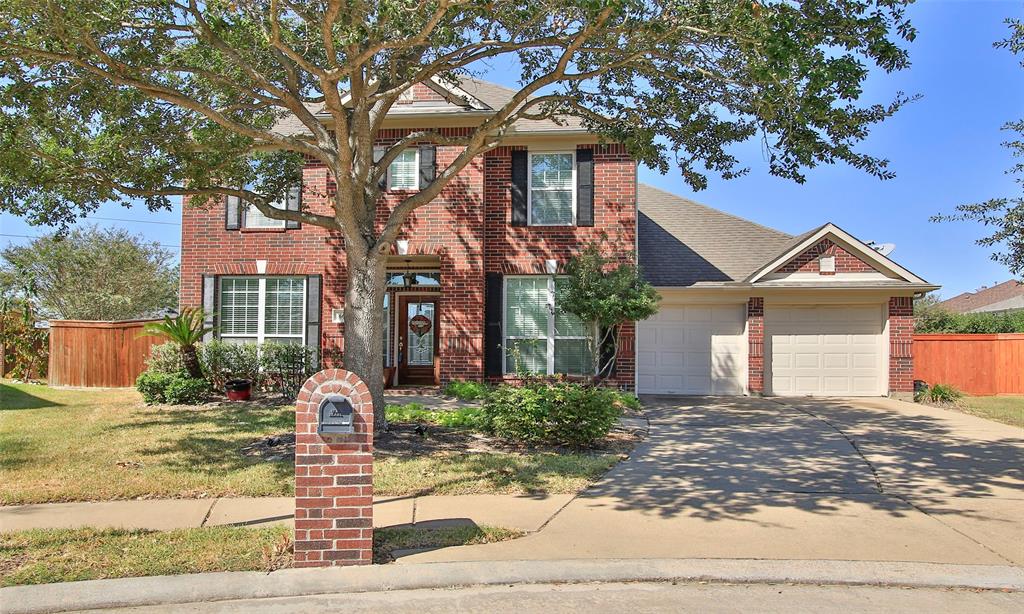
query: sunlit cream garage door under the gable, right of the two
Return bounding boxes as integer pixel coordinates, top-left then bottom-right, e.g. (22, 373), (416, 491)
(765, 305), (888, 396)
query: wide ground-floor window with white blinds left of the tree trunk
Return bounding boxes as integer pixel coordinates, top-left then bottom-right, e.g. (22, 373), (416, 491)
(219, 277), (306, 344)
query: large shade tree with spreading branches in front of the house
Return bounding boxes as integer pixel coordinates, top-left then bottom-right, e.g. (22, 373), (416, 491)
(0, 0), (914, 421)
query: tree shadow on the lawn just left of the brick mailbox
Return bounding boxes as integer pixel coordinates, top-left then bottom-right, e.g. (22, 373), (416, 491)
(104, 402), (295, 479)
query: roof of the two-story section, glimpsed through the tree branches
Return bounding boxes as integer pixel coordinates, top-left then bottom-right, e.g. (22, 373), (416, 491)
(274, 77), (587, 135)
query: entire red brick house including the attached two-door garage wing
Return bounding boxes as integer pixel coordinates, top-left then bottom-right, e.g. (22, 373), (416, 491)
(181, 79), (936, 396)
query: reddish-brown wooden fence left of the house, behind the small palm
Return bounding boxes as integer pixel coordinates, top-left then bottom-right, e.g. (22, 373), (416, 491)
(49, 319), (164, 388)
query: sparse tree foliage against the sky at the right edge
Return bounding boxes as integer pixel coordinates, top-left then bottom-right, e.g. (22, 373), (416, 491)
(932, 19), (1024, 275)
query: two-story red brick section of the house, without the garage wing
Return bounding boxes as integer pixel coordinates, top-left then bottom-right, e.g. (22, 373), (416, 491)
(181, 80), (637, 387)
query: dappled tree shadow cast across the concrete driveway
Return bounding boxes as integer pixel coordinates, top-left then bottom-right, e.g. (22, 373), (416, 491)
(582, 397), (1024, 522)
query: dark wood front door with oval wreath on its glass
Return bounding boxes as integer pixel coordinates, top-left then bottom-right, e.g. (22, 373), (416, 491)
(398, 296), (438, 385)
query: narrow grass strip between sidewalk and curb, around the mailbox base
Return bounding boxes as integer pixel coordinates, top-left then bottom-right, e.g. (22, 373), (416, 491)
(0, 526), (523, 586)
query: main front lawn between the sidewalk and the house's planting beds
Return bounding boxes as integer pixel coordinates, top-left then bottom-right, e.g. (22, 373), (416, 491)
(0, 382), (617, 505)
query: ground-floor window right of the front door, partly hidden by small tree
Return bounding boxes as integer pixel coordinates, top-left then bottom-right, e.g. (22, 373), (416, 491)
(504, 275), (593, 375)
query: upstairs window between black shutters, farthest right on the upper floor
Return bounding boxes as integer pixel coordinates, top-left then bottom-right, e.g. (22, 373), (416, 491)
(527, 152), (575, 226)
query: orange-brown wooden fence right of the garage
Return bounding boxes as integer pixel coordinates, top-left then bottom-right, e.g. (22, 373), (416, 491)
(913, 334), (1024, 394)
